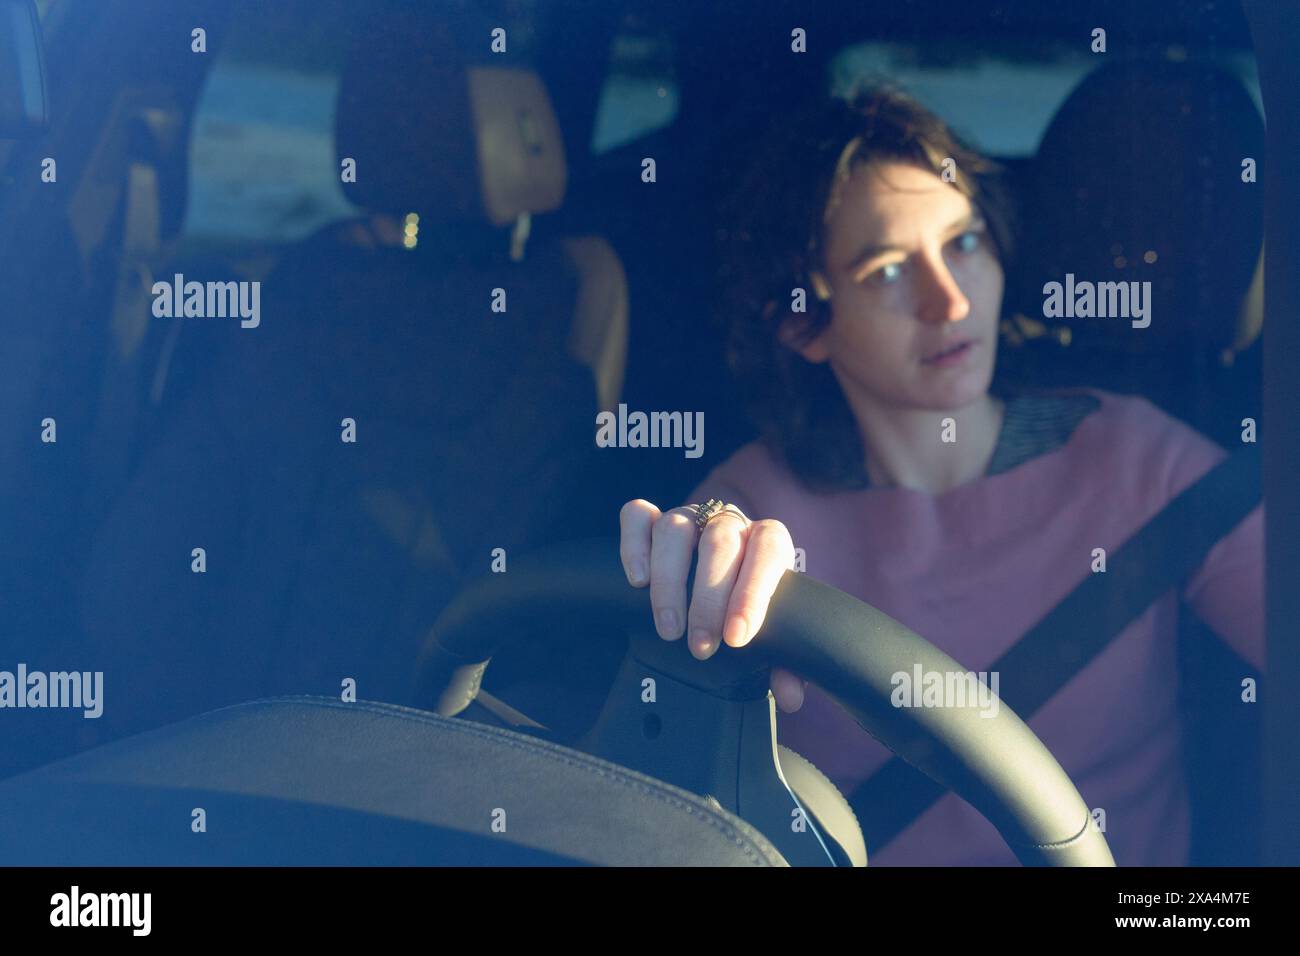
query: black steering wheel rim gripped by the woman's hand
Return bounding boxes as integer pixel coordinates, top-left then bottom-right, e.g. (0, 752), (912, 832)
(416, 538), (1114, 866)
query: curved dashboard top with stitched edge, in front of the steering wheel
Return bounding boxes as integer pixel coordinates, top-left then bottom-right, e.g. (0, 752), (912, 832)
(0, 697), (785, 866)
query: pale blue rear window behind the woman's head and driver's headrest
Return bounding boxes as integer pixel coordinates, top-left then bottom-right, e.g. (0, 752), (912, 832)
(829, 39), (1264, 157)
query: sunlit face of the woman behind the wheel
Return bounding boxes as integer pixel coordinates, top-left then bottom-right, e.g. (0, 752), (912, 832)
(780, 163), (1002, 411)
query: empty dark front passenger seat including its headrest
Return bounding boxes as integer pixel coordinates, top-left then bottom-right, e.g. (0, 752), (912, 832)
(48, 11), (637, 757)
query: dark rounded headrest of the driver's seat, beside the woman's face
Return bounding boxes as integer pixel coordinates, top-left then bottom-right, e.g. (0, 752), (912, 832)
(1023, 61), (1265, 352)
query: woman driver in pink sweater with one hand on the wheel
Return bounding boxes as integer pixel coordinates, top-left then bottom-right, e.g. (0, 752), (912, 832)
(620, 90), (1264, 865)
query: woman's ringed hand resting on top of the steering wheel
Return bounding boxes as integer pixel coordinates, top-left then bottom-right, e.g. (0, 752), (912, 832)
(619, 498), (807, 713)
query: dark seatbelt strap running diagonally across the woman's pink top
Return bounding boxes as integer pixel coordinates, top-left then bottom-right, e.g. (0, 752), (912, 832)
(849, 445), (1261, 852)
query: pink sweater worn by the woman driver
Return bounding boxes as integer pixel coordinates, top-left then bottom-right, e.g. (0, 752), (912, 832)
(689, 389), (1264, 866)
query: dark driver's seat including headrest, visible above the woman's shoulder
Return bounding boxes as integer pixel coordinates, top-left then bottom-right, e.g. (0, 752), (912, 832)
(998, 61), (1264, 445)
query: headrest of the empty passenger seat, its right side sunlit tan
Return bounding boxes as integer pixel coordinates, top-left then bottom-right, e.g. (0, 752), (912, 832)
(334, 13), (567, 226)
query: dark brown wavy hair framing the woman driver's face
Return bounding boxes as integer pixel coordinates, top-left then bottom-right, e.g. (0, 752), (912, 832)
(719, 83), (1013, 492)
